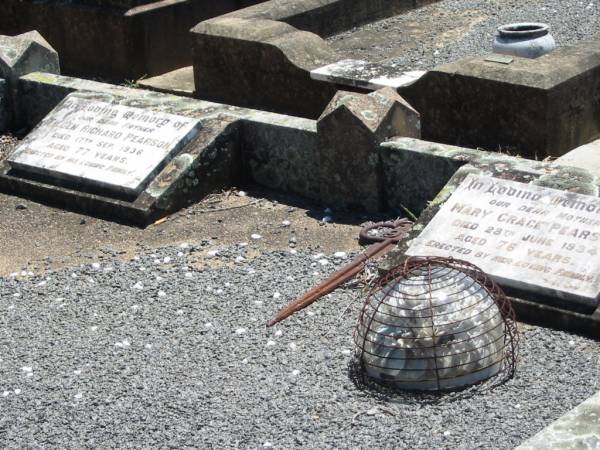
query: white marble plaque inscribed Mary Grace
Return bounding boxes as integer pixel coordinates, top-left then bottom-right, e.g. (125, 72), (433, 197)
(407, 174), (600, 307)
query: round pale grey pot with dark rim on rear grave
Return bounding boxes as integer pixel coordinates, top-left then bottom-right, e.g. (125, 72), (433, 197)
(494, 23), (556, 59)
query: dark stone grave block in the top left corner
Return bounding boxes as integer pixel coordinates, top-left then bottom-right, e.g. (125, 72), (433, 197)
(0, 0), (260, 81)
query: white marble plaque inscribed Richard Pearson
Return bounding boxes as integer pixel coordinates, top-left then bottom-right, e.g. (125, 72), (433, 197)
(8, 96), (200, 195)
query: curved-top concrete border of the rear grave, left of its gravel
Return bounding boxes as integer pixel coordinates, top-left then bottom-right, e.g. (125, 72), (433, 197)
(192, 0), (439, 118)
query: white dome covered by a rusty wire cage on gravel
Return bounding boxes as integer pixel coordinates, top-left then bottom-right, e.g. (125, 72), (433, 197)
(354, 258), (518, 391)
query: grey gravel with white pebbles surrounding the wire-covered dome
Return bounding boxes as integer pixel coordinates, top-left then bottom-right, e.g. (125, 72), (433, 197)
(0, 242), (600, 449)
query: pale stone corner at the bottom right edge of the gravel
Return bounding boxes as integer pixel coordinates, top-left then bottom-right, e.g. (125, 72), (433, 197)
(515, 392), (600, 450)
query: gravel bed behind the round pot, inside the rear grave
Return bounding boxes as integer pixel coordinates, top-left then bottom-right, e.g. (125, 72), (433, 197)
(329, 0), (600, 70)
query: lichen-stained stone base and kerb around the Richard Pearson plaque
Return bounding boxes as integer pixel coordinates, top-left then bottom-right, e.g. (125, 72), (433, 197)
(0, 73), (316, 225)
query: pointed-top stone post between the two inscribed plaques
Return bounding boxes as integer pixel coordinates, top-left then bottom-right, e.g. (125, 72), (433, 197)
(317, 88), (420, 211)
